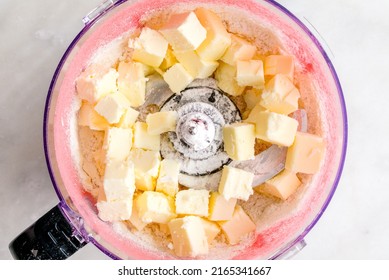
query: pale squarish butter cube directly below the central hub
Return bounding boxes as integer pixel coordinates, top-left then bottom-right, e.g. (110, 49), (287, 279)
(176, 189), (209, 217)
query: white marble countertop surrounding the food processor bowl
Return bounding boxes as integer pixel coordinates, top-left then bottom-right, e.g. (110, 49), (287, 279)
(0, 0), (389, 259)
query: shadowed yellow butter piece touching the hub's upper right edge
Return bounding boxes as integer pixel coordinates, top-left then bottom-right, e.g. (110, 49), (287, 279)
(215, 62), (245, 96)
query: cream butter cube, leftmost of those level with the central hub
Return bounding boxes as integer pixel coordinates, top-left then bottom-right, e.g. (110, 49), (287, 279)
(103, 127), (132, 161)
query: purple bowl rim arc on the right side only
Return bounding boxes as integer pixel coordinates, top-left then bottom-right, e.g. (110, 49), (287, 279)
(264, 0), (348, 259)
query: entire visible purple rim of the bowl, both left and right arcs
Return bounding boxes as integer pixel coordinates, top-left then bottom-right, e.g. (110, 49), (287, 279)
(43, 0), (348, 260)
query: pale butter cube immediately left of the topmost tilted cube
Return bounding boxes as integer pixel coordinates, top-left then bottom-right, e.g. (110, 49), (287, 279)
(129, 27), (168, 67)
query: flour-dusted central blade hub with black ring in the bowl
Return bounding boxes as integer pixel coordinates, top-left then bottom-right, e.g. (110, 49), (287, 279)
(161, 79), (241, 175)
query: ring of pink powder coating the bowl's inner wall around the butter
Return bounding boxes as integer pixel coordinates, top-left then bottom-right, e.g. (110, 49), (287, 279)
(51, 0), (343, 259)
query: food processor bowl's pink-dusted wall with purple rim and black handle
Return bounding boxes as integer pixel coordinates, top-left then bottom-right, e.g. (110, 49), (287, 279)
(10, 0), (347, 259)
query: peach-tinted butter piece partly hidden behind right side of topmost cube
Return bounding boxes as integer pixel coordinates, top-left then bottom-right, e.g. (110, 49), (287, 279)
(195, 8), (231, 61)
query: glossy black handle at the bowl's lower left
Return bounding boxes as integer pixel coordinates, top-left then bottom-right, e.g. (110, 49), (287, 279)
(9, 205), (87, 260)
